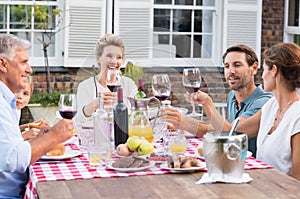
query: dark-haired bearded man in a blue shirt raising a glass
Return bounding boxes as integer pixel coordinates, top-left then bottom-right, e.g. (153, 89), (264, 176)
(161, 45), (272, 156)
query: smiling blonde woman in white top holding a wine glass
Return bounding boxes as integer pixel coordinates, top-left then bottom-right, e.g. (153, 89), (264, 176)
(75, 34), (137, 123)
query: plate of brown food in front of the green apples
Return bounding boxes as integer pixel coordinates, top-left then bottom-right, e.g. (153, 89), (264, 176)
(107, 156), (155, 172)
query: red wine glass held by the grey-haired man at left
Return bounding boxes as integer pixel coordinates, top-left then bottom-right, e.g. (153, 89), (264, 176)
(58, 94), (77, 119)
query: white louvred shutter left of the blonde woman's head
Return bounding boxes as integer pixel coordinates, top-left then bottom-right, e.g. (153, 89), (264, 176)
(64, 0), (106, 67)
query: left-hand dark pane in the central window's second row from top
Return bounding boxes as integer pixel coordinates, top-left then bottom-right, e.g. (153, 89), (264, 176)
(154, 9), (170, 32)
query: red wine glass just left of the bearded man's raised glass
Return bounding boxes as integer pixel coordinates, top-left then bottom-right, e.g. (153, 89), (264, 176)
(152, 74), (171, 103)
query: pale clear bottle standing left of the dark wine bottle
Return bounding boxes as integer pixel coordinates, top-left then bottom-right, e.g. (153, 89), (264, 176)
(93, 93), (111, 144)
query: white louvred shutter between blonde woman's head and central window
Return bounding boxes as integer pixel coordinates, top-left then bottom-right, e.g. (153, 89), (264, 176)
(114, 0), (153, 60)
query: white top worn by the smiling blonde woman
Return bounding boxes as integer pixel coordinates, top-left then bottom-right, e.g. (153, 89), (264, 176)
(74, 76), (137, 124)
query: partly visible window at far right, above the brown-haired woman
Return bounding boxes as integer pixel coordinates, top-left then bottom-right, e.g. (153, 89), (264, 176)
(284, 0), (300, 45)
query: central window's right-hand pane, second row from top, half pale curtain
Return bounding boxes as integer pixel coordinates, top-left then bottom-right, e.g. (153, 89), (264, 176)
(194, 10), (213, 33)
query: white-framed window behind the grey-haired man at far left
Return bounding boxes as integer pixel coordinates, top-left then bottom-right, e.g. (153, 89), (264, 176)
(0, 0), (59, 60)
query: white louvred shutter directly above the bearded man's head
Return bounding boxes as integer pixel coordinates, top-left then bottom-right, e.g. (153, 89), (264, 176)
(223, 0), (262, 60)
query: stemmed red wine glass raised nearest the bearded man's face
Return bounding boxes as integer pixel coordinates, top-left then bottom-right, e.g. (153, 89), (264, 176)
(182, 68), (202, 117)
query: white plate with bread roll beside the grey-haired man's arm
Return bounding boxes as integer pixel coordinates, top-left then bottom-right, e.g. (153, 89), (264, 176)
(41, 144), (82, 160)
